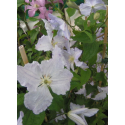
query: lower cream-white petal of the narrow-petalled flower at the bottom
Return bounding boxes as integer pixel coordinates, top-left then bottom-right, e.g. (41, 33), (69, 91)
(68, 111), (85, 125)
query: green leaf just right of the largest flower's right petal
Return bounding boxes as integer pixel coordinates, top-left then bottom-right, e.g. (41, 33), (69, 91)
(80, 69), (91, 85)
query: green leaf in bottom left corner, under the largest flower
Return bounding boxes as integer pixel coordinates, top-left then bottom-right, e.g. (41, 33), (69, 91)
(17, 104), (45, 125)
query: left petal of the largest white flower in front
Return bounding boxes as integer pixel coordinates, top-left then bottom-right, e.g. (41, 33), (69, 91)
(17, 61), (42, 91)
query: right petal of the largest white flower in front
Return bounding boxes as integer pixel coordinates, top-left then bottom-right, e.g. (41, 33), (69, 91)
(50, 69), (73, 95)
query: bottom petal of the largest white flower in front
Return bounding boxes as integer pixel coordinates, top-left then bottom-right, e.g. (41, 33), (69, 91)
(24, 85), (53, 114)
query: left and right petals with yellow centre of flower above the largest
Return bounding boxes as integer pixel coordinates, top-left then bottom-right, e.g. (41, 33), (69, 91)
(35, 35), (68, 51)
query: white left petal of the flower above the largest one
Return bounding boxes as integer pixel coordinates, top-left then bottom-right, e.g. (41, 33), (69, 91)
(35, 35), (53, 51)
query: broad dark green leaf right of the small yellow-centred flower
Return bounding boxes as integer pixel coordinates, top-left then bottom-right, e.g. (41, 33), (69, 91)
(83, 42), (99, 61)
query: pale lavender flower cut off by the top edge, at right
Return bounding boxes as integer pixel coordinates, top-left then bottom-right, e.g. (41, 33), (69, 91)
(79, 0), (106, 16)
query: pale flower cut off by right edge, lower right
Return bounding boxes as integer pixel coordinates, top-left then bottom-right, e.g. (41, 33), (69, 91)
(92, 86), (108, 100)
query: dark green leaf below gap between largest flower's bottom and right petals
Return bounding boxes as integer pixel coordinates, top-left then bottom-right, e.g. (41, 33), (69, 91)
(49, 90), (64, 111)
